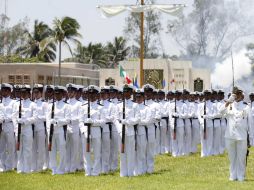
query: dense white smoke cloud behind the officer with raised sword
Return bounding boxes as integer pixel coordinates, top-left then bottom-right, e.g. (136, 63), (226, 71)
(211, 49), (251, 88)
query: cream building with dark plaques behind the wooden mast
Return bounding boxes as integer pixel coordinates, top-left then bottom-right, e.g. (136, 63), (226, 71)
(100, 59), (211, 91)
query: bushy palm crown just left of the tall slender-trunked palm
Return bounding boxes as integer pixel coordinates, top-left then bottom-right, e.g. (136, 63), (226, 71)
(17, 20), (56, 62)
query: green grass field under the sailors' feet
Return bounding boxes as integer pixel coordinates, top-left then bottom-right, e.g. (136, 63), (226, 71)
(0, 148), (254, 190)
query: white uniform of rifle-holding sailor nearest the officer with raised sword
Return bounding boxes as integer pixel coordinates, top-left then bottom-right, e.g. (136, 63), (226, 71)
(198, 100), (213, 157)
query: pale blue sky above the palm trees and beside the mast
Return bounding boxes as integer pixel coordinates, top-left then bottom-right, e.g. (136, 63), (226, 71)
(0, 0), (192, 57)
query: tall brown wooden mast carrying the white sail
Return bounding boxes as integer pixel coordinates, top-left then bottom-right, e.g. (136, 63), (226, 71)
(140, 0), (144, 88)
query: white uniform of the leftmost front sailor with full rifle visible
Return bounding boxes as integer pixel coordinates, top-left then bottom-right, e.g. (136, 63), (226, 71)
(13, 99), (37, 173)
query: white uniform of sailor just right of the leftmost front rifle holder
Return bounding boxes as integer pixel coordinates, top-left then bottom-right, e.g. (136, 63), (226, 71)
(32, 99), (48, 172)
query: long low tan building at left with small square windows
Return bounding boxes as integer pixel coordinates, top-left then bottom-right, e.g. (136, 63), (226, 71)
(0, 63), (99, 86)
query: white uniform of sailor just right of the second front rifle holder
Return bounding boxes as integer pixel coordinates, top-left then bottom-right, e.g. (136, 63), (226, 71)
(65, 98), (82, 173)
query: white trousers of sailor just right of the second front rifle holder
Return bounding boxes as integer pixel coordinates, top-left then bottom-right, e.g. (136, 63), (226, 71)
(65, 132), (80, 172)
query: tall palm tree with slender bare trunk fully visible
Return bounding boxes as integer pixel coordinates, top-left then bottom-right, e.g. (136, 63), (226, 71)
(41, 17), (81, 84)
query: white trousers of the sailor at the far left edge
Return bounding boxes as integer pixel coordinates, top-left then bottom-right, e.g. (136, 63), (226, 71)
(0, 131), (15, 171)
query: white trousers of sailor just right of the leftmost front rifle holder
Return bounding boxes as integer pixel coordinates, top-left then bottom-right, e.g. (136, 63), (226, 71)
(32, 130), (47, 171)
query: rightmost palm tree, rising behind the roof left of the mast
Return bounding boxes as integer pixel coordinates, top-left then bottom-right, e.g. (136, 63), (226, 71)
(106, 37), (130, 67)
